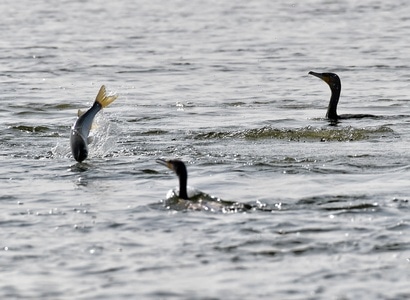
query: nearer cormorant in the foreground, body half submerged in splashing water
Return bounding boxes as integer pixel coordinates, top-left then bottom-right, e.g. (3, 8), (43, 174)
(156, 159), (252, 213)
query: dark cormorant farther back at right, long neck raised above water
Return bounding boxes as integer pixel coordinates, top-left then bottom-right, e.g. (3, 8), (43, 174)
(309, 71), (376, 121)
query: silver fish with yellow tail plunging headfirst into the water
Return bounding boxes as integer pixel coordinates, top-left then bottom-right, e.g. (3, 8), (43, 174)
(70, 85), (118, 162)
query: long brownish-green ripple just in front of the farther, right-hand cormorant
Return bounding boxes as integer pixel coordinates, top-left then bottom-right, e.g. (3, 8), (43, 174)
(194, 126), (394, 142)
